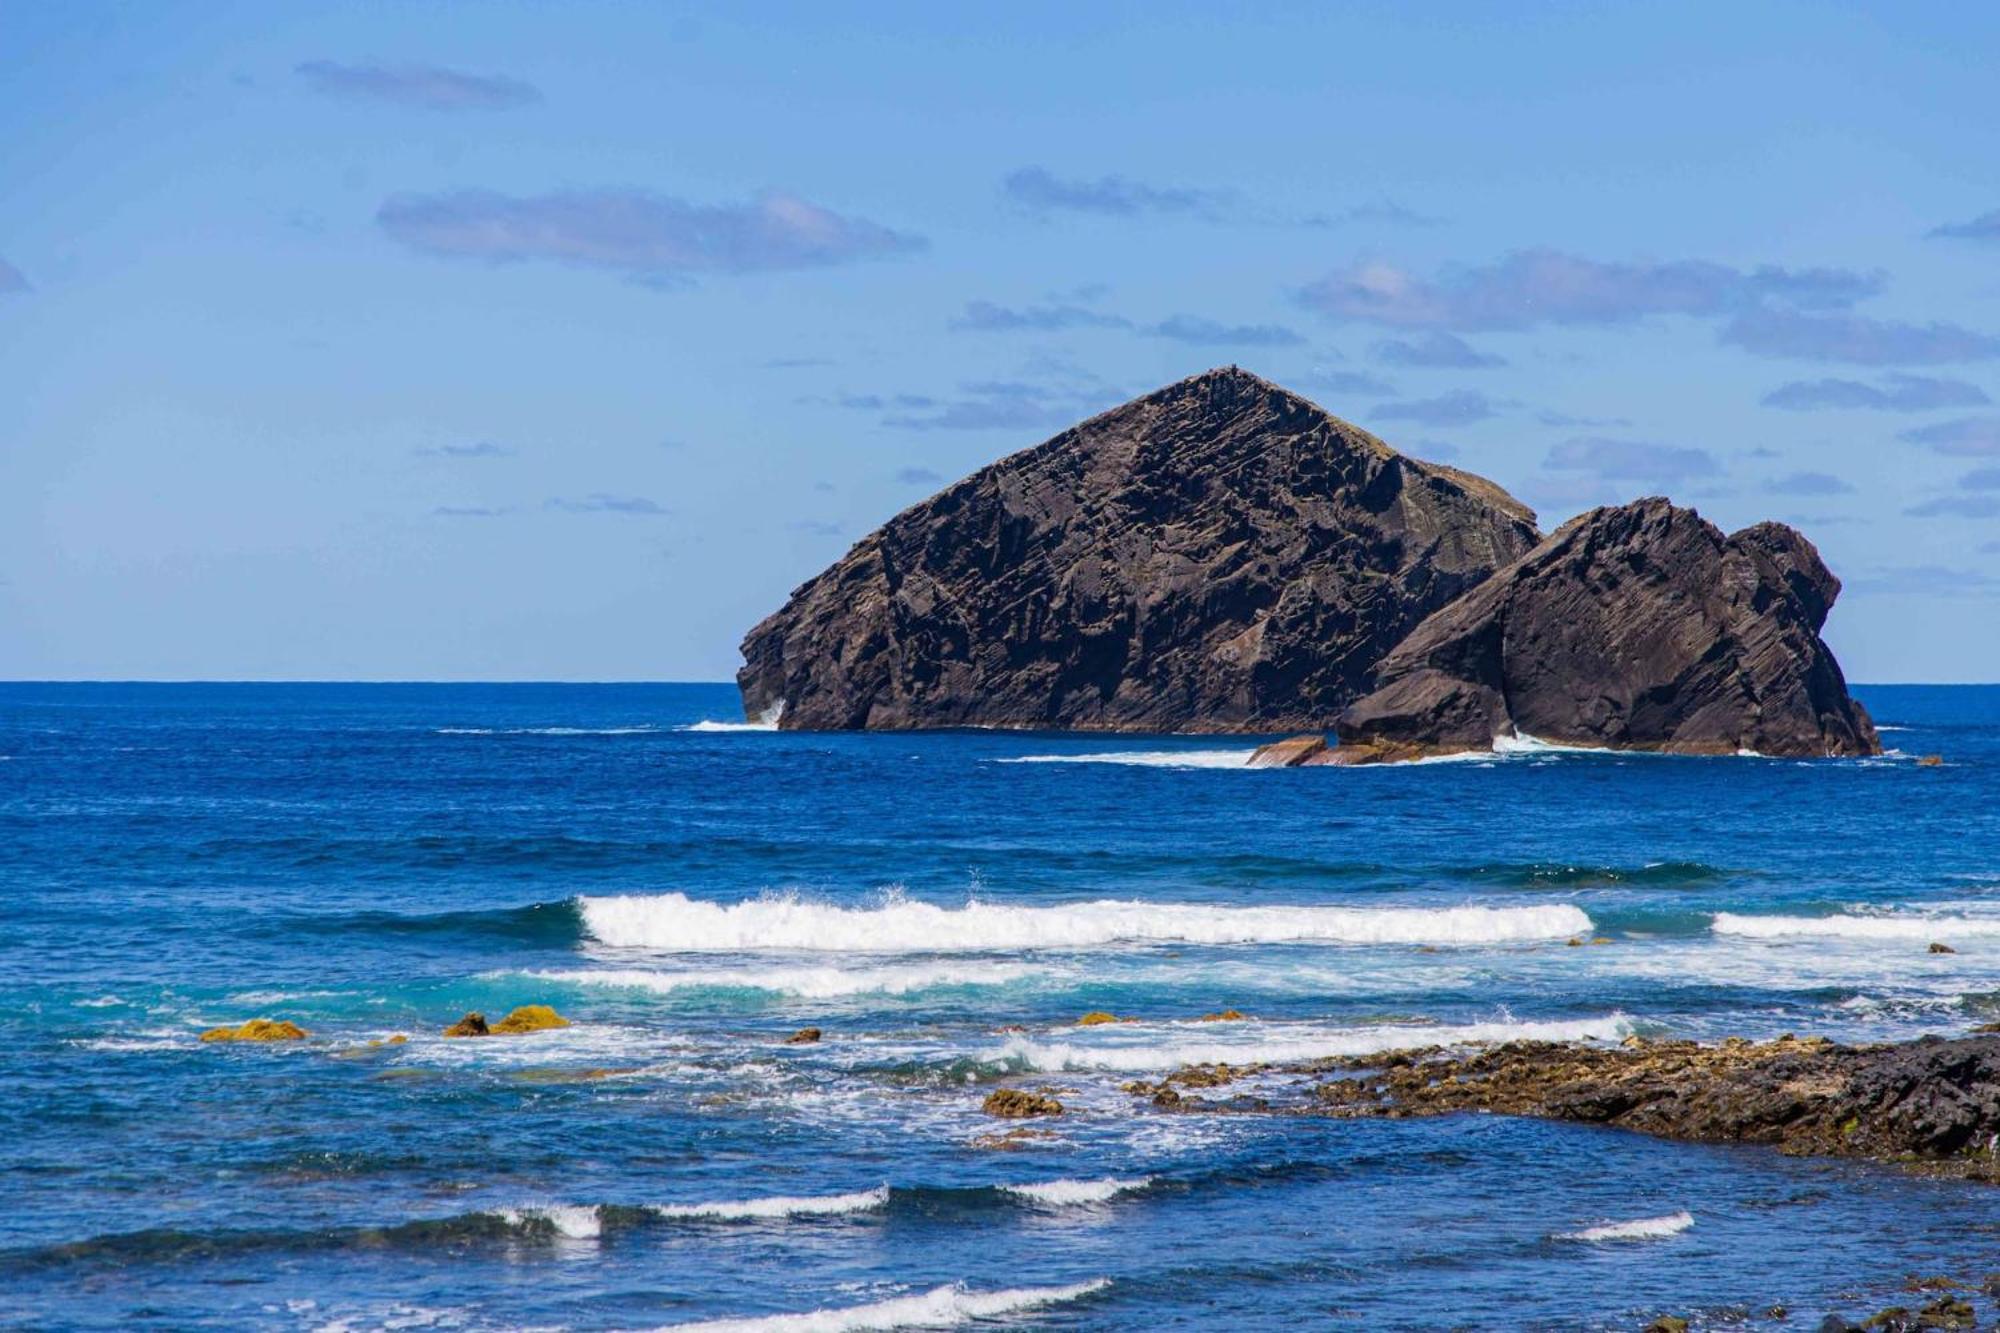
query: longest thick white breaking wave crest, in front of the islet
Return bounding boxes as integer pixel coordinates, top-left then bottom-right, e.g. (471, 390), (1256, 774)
(578, 893), (1590, 953)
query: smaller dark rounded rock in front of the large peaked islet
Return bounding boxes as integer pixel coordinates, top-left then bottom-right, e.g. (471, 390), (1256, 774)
(1336, 498), (1882, 763)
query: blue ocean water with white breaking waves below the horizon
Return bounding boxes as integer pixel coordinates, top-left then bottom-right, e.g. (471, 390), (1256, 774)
(0, 685), (2000, 1329)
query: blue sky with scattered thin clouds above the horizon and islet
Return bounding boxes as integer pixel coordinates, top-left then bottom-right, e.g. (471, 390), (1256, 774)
(0, 0), (2000, 681)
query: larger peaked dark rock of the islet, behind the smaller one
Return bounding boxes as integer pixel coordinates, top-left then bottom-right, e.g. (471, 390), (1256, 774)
(736, 368), (1538, 731)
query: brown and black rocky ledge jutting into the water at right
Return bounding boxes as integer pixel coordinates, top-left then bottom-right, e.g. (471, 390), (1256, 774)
(1316, 1037), (2000, 1181)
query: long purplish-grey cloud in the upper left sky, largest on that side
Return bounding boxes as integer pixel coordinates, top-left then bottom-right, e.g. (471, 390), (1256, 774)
(376, 190), (924, 280)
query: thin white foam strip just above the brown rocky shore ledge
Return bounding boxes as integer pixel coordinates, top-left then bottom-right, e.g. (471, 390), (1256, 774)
(982, 1013), (1632, 1073)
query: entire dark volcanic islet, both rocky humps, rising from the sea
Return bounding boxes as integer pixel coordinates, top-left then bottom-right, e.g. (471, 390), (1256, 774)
(736, 366), (1880, 767)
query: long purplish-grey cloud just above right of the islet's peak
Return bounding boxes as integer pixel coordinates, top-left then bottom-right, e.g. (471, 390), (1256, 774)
(1298, 250), (1882, 330)
